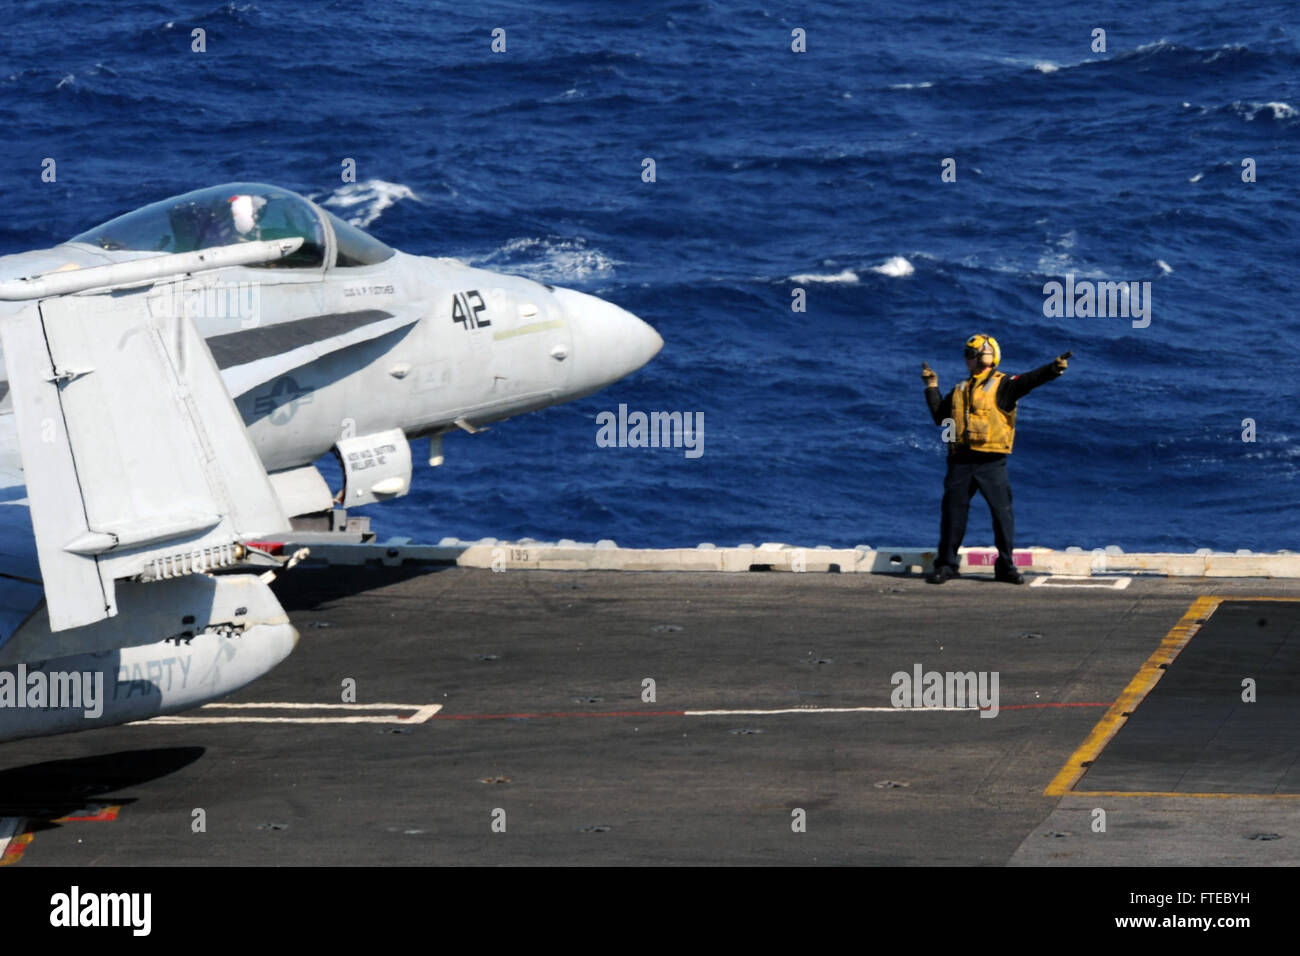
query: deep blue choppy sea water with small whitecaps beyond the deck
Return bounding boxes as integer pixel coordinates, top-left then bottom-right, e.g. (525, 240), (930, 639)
(0, 0), (1300, 550)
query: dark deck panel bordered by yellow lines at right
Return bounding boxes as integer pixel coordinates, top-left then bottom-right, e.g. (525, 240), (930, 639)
(1075, 601), (1300, 795)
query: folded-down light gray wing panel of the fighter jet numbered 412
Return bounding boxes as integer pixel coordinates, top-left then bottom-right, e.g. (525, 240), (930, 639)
(0, 280), (289, 637)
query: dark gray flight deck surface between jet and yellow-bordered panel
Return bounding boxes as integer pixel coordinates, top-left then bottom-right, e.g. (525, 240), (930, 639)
(0, 568), (1300, 868)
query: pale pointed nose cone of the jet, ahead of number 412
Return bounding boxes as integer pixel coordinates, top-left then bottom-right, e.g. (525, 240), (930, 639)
(555, 289), (663, 392)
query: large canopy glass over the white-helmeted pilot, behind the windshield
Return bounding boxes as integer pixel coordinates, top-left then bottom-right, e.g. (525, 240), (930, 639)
(72, 182), (325, 269)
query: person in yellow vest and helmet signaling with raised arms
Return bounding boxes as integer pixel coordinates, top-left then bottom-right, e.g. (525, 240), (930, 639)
(920, 334), (1074, 584)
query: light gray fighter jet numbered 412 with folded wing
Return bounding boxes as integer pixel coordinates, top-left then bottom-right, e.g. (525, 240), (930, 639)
(0, 182), (663, 740)
